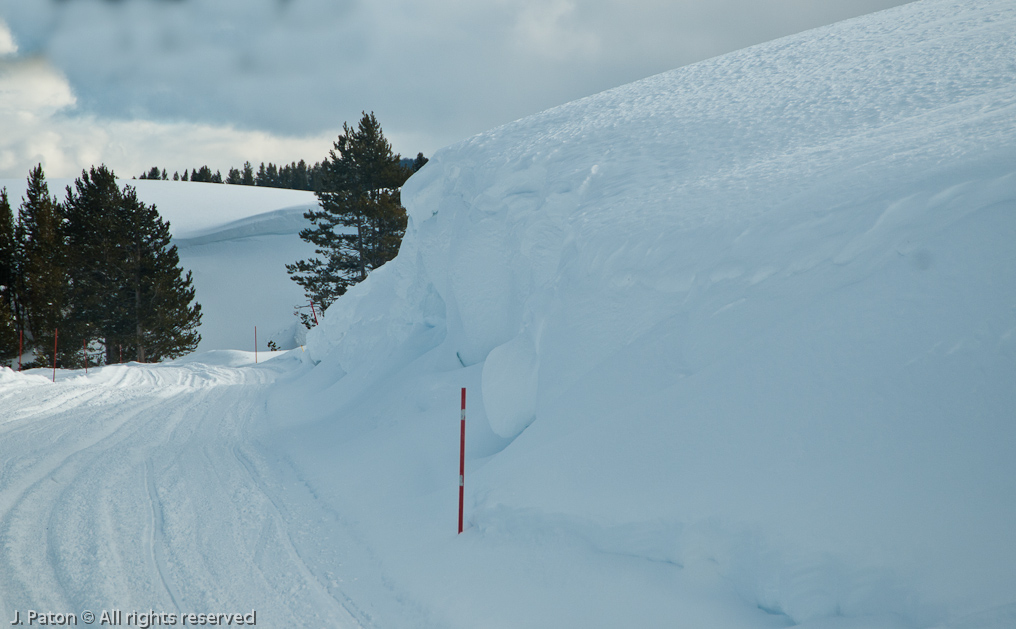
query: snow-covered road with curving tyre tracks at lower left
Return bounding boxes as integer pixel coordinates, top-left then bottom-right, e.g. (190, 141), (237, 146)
(0, 353), (370, 627)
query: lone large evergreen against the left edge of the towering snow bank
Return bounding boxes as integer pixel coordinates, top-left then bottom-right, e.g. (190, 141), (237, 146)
(287, 113), (409, 307)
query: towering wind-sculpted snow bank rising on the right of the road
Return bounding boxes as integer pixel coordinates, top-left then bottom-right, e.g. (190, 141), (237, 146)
(299, 0), (1016, 627)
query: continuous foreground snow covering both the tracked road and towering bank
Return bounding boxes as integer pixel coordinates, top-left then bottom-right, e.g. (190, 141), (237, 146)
(0, 0), (1016, 629)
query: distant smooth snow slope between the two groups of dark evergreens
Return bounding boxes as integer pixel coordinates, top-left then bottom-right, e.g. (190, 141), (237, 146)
(0, 179), (317, 352)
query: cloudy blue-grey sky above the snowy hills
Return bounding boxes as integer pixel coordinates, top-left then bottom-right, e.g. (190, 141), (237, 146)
(0, 0), (905, 178)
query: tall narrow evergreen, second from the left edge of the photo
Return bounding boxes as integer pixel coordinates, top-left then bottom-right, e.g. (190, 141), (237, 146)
(17, 165), (67, 367)
